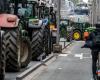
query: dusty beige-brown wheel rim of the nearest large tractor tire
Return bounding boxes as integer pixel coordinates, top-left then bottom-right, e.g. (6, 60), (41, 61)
(21, 42), (28, 63)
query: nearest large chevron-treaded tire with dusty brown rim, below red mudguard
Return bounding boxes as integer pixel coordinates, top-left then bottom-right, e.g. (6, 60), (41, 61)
(5, 29), (31, 71)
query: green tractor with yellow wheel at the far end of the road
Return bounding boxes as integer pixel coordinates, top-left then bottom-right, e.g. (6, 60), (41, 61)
(70, 19), (90, 40)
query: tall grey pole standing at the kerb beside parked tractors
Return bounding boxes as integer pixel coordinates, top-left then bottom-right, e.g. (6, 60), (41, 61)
(56, 0), (61, 44)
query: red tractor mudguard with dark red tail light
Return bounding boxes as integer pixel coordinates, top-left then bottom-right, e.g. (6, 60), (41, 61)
(0, 14), (19, 28)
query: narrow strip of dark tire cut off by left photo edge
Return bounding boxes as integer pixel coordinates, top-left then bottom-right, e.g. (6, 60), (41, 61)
(0, 32), (5, 80)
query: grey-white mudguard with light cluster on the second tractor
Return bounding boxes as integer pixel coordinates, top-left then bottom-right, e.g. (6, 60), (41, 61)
(28, 19), (43, 29)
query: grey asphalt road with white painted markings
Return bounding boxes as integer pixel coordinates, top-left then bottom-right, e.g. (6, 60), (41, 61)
(33, 41), (92, 80)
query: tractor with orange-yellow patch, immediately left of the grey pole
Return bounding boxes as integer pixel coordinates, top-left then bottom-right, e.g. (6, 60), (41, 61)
(44, 0), (57, 53)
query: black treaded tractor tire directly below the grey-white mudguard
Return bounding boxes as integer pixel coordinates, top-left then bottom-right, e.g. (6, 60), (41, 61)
(31, 28), (44, 61)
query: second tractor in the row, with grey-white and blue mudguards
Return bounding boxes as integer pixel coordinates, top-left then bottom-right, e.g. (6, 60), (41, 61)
(27, 0), (52, 60)
